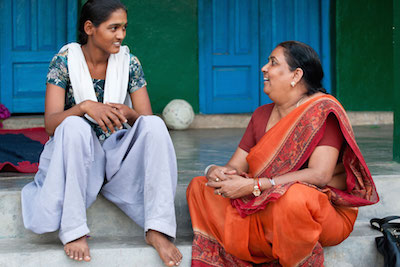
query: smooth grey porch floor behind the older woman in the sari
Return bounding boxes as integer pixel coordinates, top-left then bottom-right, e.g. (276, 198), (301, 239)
(170, 125), (400, 184)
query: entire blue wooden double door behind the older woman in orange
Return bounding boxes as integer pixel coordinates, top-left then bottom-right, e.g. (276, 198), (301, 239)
(198, 0), (331, 113)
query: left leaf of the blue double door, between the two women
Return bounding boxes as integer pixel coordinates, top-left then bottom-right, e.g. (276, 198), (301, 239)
(199, 0), (259, 113)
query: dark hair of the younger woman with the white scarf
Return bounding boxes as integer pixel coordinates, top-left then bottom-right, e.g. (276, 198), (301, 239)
(78, 0), (128, 45)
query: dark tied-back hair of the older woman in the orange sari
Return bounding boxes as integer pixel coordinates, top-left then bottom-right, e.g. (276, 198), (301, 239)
(277, 41), (326, 95)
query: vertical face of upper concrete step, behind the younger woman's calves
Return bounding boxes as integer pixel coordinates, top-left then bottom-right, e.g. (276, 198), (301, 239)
(0, 175), (400, 243)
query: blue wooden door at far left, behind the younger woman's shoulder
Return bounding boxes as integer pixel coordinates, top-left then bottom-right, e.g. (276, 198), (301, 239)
(0, 0), (78, 113)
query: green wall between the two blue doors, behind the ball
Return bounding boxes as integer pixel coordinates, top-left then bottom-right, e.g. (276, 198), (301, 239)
(80, 0), (199, 113)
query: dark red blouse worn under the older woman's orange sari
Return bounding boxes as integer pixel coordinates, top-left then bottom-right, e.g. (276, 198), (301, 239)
(239, 104), (343, 152)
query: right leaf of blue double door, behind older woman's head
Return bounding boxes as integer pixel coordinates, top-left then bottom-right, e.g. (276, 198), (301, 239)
(259, 0), (331, 104)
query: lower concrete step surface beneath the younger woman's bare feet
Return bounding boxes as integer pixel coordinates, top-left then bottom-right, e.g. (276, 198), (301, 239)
(0, 222), (383, 267)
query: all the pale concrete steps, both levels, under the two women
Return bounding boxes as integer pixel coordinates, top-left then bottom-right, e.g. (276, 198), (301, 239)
(0, 174), (394, 267)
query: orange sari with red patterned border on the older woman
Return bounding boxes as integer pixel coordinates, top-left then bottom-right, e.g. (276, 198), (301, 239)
(187, 95), (379, 266)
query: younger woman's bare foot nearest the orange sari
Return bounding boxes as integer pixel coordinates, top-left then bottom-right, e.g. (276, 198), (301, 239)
(146, 230), (182, 266)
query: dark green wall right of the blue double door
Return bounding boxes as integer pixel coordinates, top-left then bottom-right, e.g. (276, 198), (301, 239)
(335, 0), (393, 111)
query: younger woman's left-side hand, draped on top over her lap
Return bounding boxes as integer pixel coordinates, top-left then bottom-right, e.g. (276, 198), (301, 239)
(81, 100), (127, 133)
